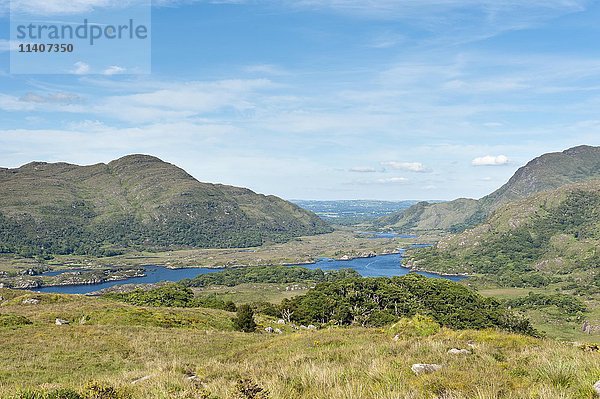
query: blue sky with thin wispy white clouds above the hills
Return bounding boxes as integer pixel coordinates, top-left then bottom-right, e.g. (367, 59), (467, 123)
(0, 0), (600, 200)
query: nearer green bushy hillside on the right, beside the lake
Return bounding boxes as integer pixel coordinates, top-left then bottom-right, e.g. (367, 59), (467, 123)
(408, 180), (600, 293)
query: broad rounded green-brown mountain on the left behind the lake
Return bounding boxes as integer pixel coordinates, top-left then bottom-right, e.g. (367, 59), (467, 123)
(0, 155), (330, 255)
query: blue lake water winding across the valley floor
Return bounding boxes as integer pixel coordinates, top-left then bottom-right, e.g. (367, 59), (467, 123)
(37, 252), (464, 294)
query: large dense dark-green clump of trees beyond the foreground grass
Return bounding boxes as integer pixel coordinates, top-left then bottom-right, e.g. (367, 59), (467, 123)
(280, 273), (531, 333)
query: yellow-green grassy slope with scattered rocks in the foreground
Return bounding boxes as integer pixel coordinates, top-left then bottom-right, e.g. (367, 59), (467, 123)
(0, 290), (600, 399)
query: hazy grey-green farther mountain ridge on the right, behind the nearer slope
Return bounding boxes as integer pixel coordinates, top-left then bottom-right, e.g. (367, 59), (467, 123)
(377, 146), (600, 232)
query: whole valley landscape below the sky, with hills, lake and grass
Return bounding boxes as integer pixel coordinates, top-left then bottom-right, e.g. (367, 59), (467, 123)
(0, 147), (600, 399)
